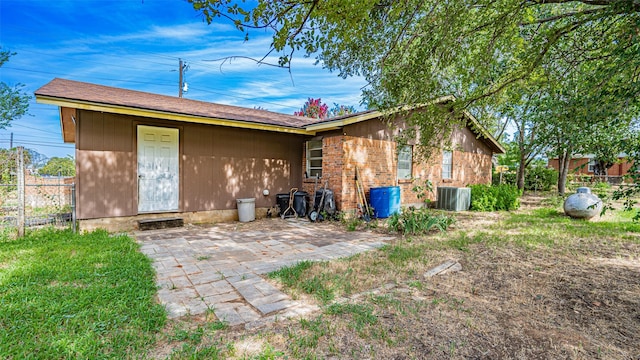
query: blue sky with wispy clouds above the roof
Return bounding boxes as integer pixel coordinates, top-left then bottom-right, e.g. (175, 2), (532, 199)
(0, 0), (365, 157)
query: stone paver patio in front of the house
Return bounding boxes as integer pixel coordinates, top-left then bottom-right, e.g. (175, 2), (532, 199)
(135, 219), (393, 327)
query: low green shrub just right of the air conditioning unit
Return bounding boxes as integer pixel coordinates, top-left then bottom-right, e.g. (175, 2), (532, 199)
(470, 185), (522, 211)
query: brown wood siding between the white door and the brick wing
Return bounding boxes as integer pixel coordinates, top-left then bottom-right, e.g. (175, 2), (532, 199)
(183, 125), (303, 211)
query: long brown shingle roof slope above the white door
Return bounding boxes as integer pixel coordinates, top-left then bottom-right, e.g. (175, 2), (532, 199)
(35, 78), (315, 129)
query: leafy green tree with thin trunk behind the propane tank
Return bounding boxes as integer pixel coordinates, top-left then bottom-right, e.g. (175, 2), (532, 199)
(530, 62), (640, 195)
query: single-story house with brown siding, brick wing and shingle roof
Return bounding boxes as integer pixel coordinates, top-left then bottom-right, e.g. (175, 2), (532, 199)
(35, 78), (504, 231)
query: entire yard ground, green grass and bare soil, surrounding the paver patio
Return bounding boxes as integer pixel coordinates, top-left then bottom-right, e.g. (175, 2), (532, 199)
(0, 201), (640, 359)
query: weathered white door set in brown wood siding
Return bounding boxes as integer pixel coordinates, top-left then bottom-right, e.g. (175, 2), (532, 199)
(138, 125), (180, 212)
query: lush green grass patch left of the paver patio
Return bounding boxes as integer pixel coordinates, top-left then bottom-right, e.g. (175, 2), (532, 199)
(0, 229), (166, 359)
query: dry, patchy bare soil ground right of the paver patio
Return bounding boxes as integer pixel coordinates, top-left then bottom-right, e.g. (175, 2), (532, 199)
(156, 198), (640, 359)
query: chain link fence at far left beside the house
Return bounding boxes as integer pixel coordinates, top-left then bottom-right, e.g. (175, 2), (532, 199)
(0, 149), (76, 234)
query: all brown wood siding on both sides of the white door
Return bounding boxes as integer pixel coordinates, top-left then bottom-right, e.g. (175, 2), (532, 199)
(76, 111), (304, 219)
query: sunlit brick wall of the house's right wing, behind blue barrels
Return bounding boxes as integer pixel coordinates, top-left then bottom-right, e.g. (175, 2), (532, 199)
(302, 122), (491, 213)
